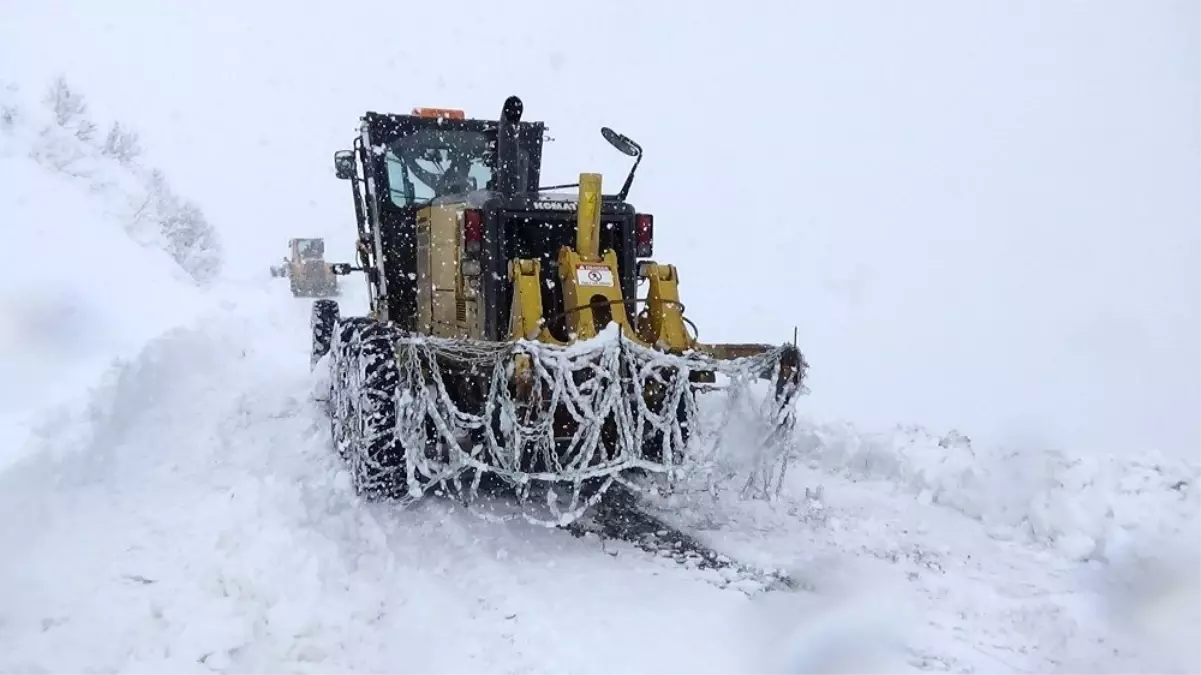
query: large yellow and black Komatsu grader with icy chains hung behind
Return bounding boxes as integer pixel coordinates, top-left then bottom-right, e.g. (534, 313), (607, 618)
(312, 96), (806, 524)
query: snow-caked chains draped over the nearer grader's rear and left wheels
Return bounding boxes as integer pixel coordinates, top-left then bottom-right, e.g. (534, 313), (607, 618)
(328, 319), (803, 526)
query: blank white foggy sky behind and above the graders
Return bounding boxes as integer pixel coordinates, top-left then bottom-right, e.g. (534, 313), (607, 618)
(0, 0), (1201, 456)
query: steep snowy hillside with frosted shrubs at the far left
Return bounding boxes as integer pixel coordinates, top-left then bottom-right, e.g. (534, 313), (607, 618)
(0, 82), (220, 466)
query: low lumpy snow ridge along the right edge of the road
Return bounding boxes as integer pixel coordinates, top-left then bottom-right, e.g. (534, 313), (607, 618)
(799, 424), (1201, 560)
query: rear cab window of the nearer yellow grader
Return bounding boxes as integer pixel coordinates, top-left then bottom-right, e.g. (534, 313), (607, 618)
(384, 129), (492, 207)
